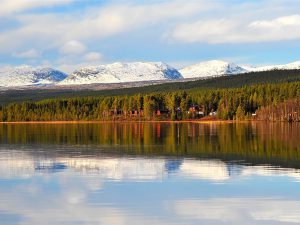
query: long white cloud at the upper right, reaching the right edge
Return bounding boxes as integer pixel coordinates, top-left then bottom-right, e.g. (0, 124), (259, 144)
(168, 15), (300, 44)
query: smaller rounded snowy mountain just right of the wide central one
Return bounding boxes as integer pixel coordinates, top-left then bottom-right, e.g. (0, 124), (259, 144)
(179, 60), (248, 78)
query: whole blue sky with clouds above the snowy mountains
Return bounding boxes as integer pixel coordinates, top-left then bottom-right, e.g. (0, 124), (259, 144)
(0, 0), (300, 72)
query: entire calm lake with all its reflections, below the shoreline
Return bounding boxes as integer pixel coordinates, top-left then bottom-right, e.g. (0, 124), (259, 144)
(0, 122), (300, 225)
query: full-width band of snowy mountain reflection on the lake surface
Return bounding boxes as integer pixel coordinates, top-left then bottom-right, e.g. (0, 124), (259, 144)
(0, 152), (300, 182)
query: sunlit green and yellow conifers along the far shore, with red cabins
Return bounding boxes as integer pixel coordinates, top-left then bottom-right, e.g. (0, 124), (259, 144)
(0, 82), (300, 121)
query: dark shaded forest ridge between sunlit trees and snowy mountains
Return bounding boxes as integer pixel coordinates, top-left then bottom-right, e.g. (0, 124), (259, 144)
(0, 70), (300, 105)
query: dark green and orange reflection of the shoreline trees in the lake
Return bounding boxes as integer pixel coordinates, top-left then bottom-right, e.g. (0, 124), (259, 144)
(0, 122), (300, 167)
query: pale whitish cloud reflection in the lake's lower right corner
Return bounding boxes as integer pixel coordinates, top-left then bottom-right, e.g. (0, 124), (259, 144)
(174, 198), (300, 224)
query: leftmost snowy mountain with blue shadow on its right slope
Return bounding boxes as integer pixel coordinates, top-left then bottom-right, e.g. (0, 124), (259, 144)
(0, 66), (67, 87)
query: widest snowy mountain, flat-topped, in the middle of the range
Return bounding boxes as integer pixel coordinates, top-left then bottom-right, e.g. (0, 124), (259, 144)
(59, 62), (183, 85)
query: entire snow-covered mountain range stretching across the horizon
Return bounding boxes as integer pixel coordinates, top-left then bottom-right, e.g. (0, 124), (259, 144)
(0, 60), (300, 88)
